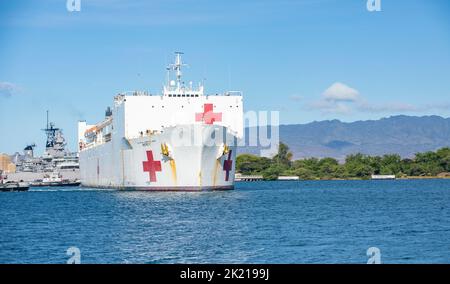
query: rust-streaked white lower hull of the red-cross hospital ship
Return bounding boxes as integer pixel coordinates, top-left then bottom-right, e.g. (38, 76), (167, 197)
(80, 124), (236, 191)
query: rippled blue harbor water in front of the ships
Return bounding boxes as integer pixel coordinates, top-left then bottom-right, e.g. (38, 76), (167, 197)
(0, 179), (450, 263)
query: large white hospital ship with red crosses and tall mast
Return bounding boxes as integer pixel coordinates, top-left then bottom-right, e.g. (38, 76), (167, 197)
(78, 52), (243, 191)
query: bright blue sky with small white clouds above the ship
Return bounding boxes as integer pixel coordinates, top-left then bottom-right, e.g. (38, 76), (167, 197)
(0, 0), (450, 153)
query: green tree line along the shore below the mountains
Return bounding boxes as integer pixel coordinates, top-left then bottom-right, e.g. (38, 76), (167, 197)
(236, 143), (450, 180)
